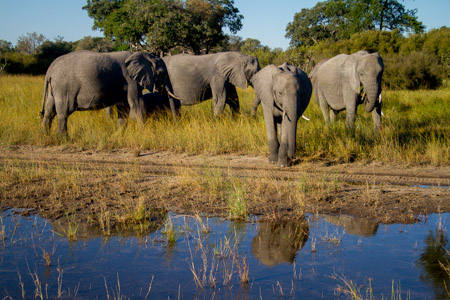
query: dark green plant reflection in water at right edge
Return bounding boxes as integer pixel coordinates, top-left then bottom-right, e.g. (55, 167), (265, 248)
(418, 228), (450, 299)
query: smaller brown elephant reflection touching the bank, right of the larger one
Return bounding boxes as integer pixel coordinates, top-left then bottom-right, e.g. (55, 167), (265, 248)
(322, 215), (378, 237)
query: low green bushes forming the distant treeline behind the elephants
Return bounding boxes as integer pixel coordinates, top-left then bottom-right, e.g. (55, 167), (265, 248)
(0, 27), (450, 90)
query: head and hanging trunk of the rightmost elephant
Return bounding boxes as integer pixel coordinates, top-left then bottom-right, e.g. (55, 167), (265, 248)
(342, 51), (384, 112)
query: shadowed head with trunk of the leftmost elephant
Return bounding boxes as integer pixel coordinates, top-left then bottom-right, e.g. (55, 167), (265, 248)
(125, 52), (179, 117)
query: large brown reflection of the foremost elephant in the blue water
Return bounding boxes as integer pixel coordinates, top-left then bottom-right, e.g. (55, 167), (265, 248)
(252, 220), (309, 267)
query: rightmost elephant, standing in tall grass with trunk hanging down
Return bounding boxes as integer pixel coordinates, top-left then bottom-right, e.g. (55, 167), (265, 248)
(310, 51), (384, 130)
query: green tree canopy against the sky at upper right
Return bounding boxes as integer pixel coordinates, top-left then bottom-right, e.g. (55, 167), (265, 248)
(286, 0), (425, 46)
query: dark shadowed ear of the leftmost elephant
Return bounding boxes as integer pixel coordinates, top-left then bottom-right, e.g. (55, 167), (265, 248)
(125, 52), (156, 91)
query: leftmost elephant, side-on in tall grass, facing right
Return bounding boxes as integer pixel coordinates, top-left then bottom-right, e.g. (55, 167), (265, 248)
(41, 51), (175, 135)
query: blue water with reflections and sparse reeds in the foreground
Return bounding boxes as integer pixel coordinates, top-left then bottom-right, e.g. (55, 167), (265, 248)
(0, 211), (450, 299)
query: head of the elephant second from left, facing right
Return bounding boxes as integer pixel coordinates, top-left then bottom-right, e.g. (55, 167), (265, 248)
(216, 52), (261, 89)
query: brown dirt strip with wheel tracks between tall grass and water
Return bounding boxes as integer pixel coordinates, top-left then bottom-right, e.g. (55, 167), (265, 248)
(0, 146), (450, 227)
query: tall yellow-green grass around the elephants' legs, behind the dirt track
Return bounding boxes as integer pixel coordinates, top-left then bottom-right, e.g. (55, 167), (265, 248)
(0, 76), (450, 165)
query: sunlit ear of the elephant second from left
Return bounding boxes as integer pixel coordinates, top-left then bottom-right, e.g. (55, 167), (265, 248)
(216, 52), (247, 89)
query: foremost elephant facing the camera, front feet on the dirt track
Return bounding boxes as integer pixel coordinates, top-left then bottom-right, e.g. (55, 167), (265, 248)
(252, 64), (312, 167)
